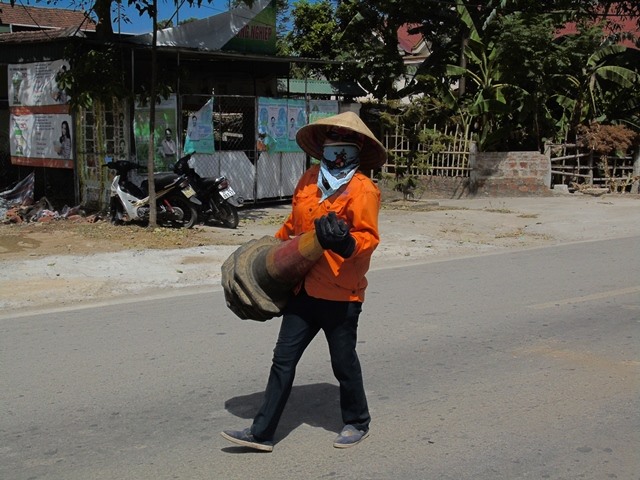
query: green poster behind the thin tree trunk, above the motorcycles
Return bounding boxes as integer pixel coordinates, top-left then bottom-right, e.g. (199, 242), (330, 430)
(133, 95), (177, 172)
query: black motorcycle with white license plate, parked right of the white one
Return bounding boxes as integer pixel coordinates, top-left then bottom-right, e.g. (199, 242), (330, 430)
(173, 154), (242, 228)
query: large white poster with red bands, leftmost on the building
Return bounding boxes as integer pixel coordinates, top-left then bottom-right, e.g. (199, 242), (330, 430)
(7, 60), (74, 168)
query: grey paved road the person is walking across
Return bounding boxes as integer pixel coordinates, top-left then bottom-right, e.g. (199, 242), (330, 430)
(0, 237), (640, 480)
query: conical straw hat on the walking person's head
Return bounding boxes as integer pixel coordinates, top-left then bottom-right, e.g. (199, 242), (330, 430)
(296, 112), (387, 170)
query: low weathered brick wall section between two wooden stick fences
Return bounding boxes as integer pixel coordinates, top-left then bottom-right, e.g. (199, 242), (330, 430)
(469, 152), (551, 197)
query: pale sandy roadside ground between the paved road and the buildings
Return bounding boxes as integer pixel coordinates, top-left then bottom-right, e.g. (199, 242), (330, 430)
(0, 194), (640, 317)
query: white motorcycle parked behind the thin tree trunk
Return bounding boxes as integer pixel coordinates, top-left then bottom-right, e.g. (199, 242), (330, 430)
(103, 160), (200, 228)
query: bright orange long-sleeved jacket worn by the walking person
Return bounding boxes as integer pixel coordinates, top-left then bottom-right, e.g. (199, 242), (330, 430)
(275, 165), (380, 302)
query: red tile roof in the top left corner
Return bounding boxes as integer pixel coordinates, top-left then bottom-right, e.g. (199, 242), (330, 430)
(0, 3), (96, 31)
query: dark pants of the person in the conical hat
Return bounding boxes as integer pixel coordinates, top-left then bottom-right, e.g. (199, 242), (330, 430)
(251, 290), (371, 440)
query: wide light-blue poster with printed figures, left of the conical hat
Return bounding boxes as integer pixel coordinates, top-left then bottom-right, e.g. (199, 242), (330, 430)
(257, 97), (307, 152)
